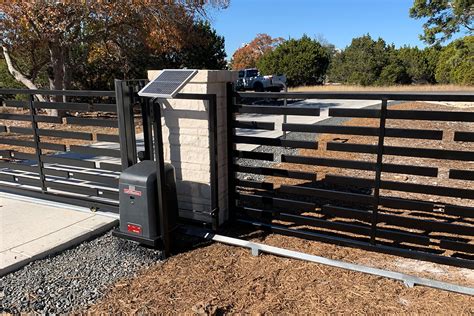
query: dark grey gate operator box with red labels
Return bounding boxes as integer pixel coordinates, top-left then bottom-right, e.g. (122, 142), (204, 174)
(119, 160), (178, 246)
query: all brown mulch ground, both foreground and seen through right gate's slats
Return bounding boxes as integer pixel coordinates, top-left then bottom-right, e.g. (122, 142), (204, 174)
(88, 103), (474, 315)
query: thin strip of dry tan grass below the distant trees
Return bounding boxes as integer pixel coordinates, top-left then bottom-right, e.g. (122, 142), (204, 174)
(289, 85), (474, 92)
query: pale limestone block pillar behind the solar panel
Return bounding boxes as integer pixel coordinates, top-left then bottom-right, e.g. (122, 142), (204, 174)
(148, 70), (237, 223)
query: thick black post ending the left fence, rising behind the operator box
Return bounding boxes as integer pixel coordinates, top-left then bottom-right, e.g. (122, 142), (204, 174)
(115, 79), (137, 170)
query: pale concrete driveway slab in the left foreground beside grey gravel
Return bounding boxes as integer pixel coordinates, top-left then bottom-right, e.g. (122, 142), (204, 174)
(0, 192), (118, 276)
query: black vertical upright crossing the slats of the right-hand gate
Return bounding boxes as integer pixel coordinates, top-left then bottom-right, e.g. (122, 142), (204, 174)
(371, 99), (387, 244)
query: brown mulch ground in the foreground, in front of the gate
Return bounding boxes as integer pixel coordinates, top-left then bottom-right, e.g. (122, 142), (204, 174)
(87, 235), (474, 315)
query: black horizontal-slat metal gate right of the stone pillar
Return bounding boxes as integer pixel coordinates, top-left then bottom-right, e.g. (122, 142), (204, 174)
(228, 86), (474, 268)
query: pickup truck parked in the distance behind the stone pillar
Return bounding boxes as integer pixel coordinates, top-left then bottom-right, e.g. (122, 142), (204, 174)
(236, 68), (286, 92)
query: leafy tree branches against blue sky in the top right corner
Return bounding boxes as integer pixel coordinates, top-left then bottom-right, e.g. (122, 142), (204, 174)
(410, 0), (474, 44)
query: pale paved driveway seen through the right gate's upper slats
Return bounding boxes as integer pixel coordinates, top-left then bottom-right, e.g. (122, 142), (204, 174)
(236, 99), (380, 151)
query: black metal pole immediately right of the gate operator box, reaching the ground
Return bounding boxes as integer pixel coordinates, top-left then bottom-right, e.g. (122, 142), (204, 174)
(151, 102), (171, 257)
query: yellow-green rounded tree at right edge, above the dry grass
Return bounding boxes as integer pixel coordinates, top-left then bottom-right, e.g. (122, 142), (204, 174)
(436, 36), (474, 85)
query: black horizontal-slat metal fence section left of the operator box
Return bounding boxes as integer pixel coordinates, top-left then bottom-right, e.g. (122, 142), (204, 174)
(0, 89), (122, 212)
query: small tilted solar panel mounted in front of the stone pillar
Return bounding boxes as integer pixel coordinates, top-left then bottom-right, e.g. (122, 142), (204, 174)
(138, 69), (197, 99)
